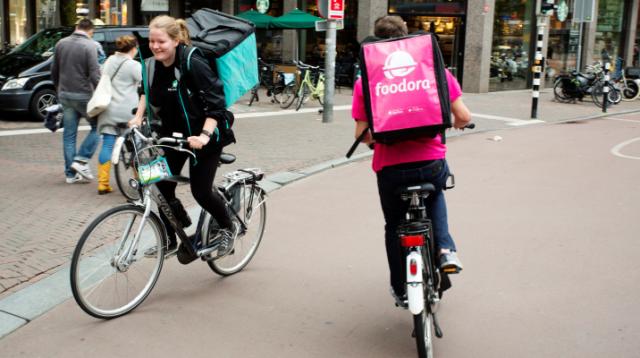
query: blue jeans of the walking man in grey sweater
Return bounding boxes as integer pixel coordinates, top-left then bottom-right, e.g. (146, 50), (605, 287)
(59, 92), (100, 178)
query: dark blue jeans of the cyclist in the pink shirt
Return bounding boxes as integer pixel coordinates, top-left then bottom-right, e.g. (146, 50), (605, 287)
(377, 159), (456, 294)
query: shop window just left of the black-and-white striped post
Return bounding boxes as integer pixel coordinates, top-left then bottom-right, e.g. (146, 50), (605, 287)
(489, 0), (535, 91)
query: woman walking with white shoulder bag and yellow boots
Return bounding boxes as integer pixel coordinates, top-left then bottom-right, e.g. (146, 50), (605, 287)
(98, 35), (142, 194)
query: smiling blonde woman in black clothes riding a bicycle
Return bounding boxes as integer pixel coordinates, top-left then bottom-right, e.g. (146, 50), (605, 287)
(130, 15), (239, 264)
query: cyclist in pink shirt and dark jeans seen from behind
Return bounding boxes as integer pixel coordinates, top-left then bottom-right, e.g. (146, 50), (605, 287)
(352, 16), (471, 306)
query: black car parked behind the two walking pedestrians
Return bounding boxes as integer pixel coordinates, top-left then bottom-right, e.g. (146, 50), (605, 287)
(0, 26), (151, 120)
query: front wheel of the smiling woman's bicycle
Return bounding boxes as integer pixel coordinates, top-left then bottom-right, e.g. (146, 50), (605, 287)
(70, 205), (164, 319)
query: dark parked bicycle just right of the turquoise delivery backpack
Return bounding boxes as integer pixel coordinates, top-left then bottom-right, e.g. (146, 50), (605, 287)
(249, 58), (295, 108)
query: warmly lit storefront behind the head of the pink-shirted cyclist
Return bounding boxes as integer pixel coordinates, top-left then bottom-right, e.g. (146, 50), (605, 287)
(389, 0), (467, 82)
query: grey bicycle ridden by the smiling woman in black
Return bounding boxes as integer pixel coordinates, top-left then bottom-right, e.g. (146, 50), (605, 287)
(70, 128), (266, 319)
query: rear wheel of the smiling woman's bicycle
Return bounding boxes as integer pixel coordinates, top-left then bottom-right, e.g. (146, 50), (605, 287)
(207, 184), (267, 276)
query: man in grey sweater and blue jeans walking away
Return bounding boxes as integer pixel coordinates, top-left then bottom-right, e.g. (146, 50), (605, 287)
(51, 19), (100, 184)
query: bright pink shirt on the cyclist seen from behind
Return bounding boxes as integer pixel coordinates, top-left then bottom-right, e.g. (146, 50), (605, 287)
(351, 70), (462, 172)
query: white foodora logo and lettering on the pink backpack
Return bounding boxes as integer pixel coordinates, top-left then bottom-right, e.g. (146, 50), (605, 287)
(376, 50), (431, 96)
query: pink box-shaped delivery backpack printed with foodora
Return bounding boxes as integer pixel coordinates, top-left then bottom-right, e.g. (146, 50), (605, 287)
(347, 33), (451, 156)
